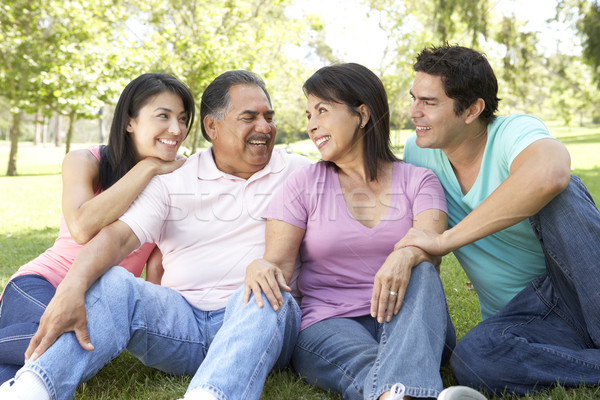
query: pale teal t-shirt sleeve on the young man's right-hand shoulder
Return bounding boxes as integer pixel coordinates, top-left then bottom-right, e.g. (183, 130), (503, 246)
(496, 115), (553, 168)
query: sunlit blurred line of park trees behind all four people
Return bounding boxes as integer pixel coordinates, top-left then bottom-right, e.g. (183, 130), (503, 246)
(0, 0), (600, 175)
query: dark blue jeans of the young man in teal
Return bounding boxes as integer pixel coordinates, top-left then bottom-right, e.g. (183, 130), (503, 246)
(450, 176), (600, 394)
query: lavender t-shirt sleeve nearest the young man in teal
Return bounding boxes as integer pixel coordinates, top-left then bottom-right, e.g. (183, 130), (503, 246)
(412, 168), (448, 215)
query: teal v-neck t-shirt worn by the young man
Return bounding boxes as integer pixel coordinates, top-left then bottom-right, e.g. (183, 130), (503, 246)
(404, 115), (552, 319)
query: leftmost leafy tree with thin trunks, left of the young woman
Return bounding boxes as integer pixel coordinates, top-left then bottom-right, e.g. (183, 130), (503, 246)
(0, 0), (138, 175)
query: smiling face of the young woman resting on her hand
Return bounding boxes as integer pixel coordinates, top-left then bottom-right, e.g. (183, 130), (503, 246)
(127, 92), (187, 161)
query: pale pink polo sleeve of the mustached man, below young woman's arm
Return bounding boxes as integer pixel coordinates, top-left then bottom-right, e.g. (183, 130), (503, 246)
(119, 176), (169, 245)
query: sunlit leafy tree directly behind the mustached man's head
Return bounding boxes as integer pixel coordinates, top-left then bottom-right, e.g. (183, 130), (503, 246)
(137, 0), (321, 152)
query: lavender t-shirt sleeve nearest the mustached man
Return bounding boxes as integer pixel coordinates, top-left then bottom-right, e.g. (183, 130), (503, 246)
(262, 168), (308, 230)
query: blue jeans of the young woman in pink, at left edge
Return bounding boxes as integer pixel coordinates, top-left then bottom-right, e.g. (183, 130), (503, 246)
(0, 274), (56, 384)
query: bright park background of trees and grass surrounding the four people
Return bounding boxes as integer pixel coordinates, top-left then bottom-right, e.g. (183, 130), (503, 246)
(0, 0), (600, 400)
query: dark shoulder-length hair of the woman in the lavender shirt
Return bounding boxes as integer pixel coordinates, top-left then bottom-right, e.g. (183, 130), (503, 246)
(302, 63), (398, 180)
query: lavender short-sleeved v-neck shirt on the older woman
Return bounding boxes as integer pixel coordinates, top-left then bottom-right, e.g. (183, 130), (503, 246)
(263, 162), (447, 329)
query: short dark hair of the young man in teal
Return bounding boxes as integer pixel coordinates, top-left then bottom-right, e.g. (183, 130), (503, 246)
(414, 44), (500, 124)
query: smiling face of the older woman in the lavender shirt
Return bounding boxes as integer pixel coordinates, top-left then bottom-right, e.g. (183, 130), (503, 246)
(306, 94), (360, 165)
